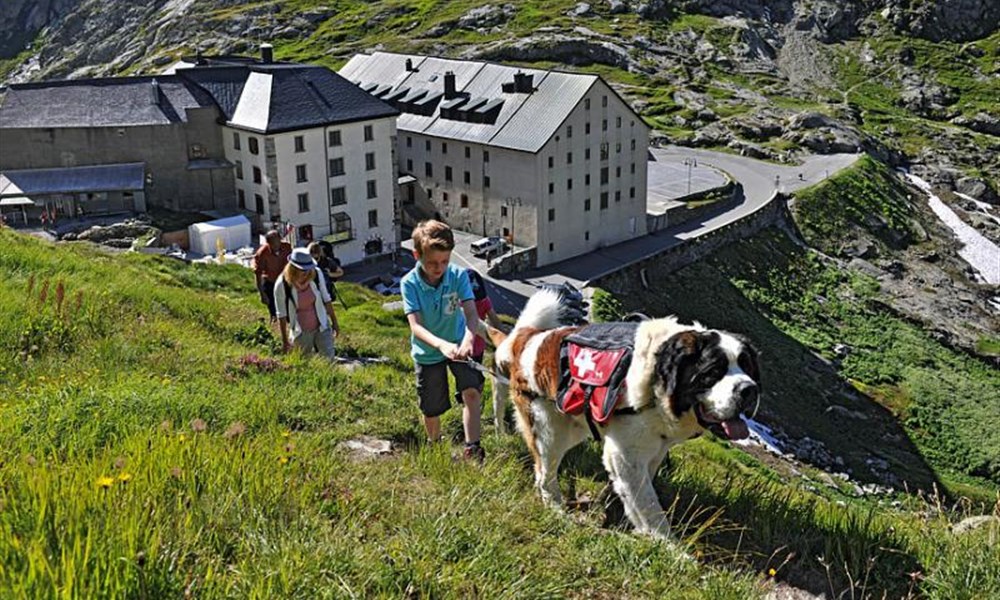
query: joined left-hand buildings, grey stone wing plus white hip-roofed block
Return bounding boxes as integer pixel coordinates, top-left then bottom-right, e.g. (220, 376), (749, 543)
(0, 47), (398, 263)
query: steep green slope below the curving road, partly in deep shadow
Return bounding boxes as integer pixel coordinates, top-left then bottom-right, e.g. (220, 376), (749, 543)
(626, 158), (1000, 497)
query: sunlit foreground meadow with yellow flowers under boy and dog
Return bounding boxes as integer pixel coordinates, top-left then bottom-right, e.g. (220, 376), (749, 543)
(0, 224), (1000, 598)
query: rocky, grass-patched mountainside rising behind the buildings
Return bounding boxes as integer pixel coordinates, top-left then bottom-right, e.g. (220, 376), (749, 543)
(0, 0), (1000, 202)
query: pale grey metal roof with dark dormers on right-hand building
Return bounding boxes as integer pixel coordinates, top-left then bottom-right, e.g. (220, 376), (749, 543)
(340, 52), (600, 152)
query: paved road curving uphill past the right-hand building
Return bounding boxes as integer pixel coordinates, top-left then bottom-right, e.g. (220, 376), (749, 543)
(478, 146), (860, 315)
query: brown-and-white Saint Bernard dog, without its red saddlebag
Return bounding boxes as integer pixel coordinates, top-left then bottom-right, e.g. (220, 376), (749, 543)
(487, 290), (760, 538)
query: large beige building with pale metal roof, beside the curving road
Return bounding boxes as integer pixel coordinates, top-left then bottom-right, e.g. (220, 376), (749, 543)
(340, 52), (649, 266)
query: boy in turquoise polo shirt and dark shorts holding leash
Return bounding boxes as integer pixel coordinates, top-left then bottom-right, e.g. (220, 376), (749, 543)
(400, 220), (486, 462)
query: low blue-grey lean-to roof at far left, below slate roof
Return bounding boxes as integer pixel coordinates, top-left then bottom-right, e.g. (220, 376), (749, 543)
(0, 163), (145, 197)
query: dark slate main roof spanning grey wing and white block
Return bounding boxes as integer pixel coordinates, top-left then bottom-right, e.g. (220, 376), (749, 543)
(0, 62), (398, 133)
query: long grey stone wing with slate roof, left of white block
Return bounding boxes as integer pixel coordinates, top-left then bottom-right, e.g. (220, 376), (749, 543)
(0, 76), (227, 214)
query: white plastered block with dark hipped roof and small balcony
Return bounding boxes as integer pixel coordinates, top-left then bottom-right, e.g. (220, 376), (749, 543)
(182, 60), (399, 264)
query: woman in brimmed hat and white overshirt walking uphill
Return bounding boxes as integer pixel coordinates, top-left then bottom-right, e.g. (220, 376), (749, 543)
(274, 248), (340, 360)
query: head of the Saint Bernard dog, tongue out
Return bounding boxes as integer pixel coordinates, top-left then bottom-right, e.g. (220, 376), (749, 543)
(655, 330), (760, 440)
